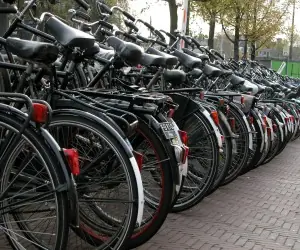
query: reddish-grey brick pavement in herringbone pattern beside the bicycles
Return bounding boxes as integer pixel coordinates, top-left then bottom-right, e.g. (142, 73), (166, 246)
(138, 141), (300, 250)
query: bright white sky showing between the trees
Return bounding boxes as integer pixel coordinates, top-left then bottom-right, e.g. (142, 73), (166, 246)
(130, 0), (300, 37)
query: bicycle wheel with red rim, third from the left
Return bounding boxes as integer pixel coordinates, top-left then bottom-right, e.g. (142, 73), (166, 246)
(125, 120), (175, 249)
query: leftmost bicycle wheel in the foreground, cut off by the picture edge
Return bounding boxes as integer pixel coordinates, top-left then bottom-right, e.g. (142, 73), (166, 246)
(0, 113), (69, 249)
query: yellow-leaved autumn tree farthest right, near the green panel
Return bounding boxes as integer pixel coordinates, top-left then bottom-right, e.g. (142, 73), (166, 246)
(220, 0), (291, 60)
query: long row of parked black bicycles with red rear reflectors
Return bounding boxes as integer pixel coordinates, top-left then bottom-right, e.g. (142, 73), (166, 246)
(0, 0), (300, 249)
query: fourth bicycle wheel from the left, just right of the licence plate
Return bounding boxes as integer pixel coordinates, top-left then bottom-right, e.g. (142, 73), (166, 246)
(172, 112), (219, 212)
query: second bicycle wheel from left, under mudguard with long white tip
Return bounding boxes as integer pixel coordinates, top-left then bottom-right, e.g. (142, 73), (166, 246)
(49, 113), (139, 249)
